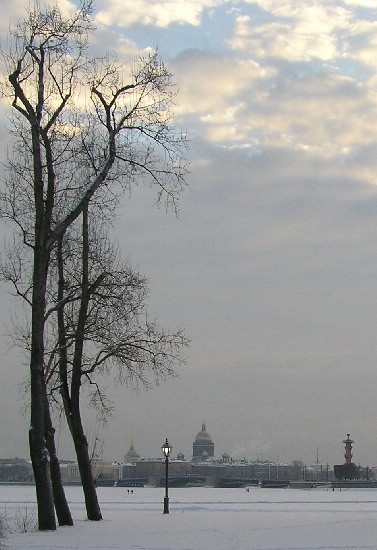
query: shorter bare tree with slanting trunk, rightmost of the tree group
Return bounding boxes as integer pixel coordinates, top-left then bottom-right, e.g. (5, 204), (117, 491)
(45, 208), (188, 519)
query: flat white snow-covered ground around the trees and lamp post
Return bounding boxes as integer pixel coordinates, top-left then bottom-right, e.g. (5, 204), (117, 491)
(0, 485), (377, 550)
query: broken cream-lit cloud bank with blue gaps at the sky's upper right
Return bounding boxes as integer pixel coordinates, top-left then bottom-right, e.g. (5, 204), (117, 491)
(159, 0), (377, 158)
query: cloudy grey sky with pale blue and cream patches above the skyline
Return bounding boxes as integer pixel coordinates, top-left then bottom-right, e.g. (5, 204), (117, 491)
(0, 0), (377, 466)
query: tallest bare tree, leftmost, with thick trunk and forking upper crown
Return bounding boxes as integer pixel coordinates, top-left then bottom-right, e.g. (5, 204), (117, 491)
(2, 0), (186, 530)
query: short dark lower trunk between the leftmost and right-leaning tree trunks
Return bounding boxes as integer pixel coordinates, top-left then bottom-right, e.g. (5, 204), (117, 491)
(45, 401), (73, 526)
